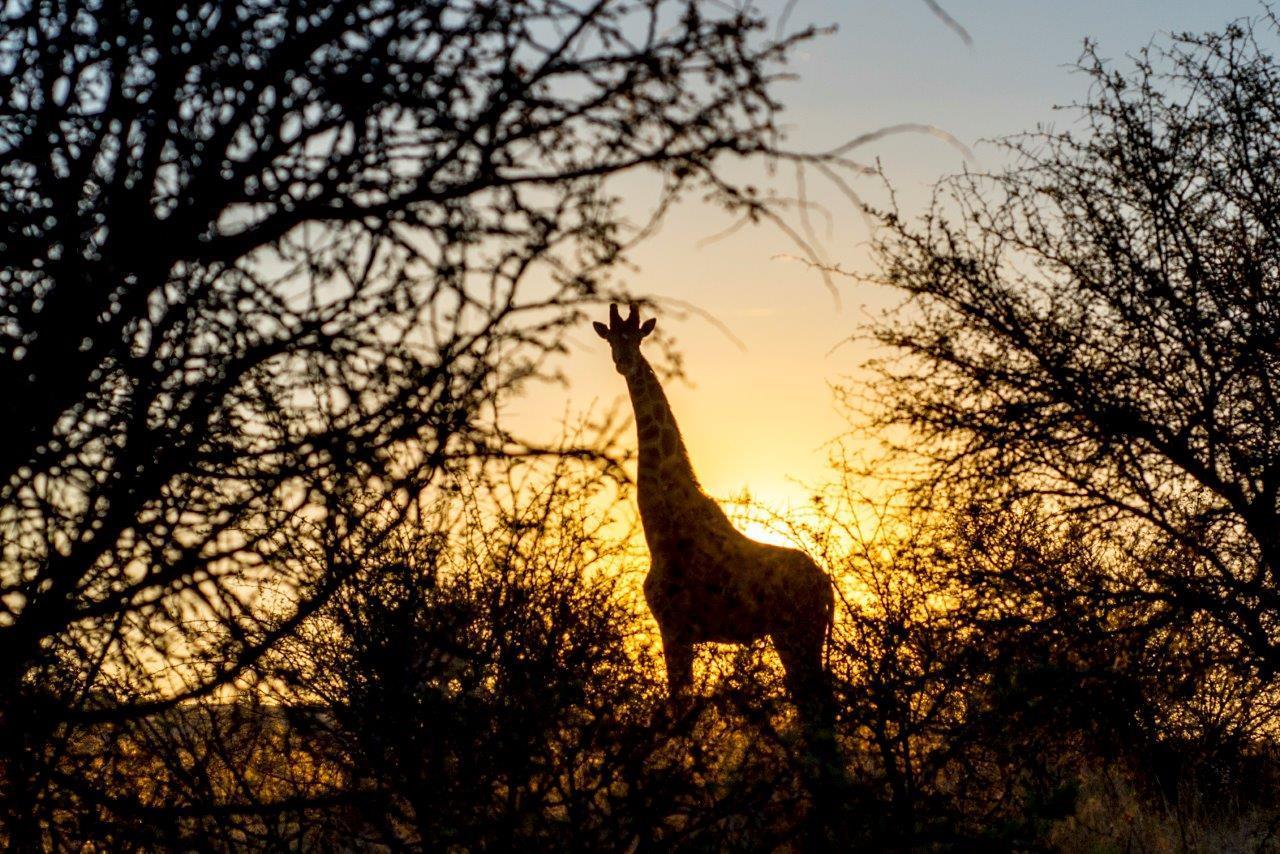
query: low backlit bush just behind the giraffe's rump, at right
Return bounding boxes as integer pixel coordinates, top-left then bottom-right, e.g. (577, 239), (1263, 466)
(780, 468), (1280, 848)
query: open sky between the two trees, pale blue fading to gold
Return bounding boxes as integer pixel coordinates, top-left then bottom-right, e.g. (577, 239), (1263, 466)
(513, 0), (1262, 533)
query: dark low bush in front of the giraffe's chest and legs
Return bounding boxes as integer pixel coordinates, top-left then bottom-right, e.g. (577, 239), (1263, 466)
(282, 463), (829, 850)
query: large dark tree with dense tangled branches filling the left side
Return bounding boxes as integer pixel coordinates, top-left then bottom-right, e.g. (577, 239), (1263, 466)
(0, 0), (829, 840)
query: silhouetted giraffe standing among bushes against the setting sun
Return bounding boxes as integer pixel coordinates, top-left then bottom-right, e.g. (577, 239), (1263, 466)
(594, 305), (835, 730)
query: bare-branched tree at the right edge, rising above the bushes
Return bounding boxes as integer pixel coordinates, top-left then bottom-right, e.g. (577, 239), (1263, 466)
(878, 14), (1280, 680)
